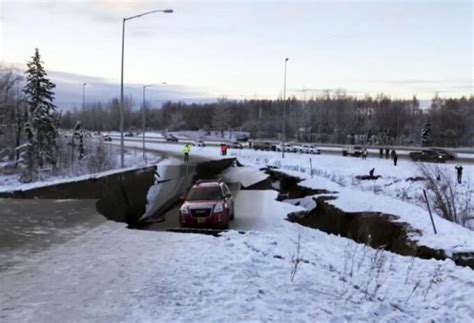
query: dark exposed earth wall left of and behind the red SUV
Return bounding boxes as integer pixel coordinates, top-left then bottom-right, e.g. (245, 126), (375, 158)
(0, 158), (234, 227)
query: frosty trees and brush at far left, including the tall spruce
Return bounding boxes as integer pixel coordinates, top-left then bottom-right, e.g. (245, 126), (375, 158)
(0, 49), (114, 182)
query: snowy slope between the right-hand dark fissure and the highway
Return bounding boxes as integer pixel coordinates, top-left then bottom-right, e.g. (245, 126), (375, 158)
(120, 142), (474, 254)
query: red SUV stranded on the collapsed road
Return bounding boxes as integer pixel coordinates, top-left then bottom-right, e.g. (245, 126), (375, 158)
(179, 180), (234, 229)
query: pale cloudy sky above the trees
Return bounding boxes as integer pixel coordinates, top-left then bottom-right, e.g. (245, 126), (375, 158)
(0, 0), (474, 105)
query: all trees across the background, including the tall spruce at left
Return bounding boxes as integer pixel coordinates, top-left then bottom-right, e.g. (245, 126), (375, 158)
(0, 54), (474, 186)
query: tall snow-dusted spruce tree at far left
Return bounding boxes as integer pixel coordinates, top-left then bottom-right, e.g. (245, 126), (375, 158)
(23, 48), (58, 169)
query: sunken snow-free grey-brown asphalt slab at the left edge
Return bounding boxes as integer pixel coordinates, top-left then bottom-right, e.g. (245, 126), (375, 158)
(0, 199), (107, 271)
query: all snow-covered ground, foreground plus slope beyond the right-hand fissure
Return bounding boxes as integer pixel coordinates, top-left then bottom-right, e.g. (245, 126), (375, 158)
(0, 139), (474, 322)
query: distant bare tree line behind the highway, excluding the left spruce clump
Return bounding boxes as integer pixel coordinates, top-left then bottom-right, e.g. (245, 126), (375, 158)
(61, 90), (474, 147)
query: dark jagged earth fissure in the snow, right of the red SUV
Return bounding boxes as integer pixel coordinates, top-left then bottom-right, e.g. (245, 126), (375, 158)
(268, 170), (474, 269)
